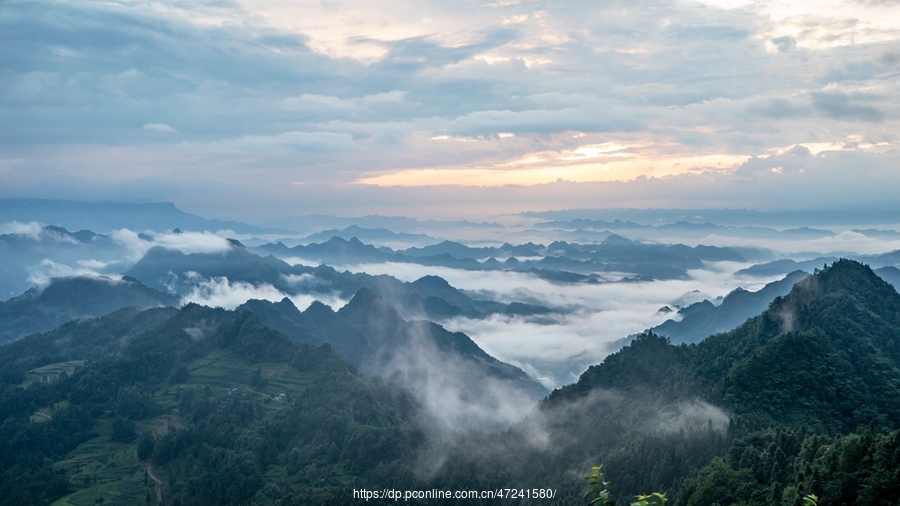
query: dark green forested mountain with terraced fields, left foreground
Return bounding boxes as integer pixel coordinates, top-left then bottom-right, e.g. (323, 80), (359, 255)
(0, 304), (428, 505)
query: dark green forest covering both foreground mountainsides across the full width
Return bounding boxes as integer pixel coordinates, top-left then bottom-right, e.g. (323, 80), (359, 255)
(0, 260), (900, 506)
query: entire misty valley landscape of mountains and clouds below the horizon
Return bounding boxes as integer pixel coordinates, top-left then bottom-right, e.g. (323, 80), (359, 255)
(0, 203), (900, 506)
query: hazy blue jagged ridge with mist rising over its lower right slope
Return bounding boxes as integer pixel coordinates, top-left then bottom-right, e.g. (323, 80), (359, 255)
(238, 288), (547, 429)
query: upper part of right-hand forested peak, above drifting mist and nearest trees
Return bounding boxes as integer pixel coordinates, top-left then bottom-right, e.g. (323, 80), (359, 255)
(564, 260), (900, 433)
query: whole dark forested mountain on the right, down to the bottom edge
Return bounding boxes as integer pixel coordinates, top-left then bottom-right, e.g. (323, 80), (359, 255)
(435, 260), (900, 506)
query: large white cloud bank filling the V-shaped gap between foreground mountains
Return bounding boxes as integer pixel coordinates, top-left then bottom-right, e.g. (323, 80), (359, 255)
(328, 263), (775, 387)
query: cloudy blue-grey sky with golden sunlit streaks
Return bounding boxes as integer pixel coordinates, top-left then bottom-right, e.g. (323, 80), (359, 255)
(0, 0), (900, 219)
